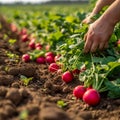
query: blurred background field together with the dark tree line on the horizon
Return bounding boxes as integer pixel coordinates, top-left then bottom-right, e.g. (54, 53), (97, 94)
(0, 1), (91, 17)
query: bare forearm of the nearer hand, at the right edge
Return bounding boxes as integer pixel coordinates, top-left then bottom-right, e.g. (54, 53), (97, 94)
(100, 0), (120, 26)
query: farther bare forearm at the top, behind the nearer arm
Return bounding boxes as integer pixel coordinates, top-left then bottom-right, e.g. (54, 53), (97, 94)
(91, 0), (115, 16)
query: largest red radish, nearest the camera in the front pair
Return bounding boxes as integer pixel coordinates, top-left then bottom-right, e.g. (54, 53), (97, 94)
(83, 89), (100, 106)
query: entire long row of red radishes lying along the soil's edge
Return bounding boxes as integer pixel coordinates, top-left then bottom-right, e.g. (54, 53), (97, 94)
(10, 24), (100, 106)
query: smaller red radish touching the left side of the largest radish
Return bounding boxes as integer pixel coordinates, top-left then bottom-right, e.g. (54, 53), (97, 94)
(73, 85), (86, 99)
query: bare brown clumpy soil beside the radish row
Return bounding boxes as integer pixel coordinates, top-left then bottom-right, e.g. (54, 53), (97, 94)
(0, 17), (120, 120)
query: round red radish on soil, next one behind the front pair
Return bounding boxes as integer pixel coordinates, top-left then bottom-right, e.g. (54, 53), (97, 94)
(62, 71), (73, 83)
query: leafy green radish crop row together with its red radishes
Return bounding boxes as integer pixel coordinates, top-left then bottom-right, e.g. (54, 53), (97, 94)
(8, 7), (120, 105)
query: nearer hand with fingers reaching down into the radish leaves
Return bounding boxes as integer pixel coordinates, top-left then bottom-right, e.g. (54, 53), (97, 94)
(84, 19), (114, 53)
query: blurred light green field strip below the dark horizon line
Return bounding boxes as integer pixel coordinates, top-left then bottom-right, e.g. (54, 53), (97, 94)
(0, 3), (91, 16)
